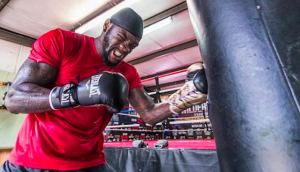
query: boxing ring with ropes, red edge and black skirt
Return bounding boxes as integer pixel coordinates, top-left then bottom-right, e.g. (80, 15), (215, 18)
(104, 107), (220, 172)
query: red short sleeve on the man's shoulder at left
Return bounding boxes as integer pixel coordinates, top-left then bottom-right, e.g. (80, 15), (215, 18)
(28, 29), (64, 68)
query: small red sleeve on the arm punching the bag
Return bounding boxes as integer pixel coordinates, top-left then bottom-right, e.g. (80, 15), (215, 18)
(127, 64), (143, 90)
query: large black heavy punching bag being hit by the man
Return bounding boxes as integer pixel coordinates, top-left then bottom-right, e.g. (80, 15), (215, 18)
(187, 0), (300, 172)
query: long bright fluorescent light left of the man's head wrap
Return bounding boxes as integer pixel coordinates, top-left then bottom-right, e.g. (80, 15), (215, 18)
(75, 0), (139, 33)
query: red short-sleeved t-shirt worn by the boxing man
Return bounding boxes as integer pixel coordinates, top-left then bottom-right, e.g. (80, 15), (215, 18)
(9, 29), (142, 170)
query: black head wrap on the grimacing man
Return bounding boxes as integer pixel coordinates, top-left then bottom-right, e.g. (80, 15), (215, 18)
(110, 8), (143, 39)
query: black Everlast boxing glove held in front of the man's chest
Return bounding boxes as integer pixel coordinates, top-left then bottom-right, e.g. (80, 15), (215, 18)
(49, 72), (129, 113)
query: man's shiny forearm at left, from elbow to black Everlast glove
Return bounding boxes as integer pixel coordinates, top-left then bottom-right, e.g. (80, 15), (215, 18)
(5, 83), (52, 113)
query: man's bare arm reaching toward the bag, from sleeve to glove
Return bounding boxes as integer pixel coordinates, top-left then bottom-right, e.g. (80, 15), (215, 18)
(129, 87), (172, 125)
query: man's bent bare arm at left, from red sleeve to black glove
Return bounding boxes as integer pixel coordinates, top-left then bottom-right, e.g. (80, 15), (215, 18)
(5, 59), (58, 113)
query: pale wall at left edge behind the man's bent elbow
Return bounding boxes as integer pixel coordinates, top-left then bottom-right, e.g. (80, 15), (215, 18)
(0, 39), (31, 147)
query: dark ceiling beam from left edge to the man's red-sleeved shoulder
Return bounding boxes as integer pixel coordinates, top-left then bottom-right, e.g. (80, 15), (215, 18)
(0, 28), (36, 47)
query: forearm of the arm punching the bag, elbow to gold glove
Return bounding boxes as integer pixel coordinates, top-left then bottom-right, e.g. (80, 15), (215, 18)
(139, 103), (173, 125)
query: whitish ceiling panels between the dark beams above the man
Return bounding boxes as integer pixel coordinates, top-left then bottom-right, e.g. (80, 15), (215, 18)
(0, 0), (202, 93)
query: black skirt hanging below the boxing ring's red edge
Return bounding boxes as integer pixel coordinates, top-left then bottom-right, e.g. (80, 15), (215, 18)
(104, 143), (220, 172)
